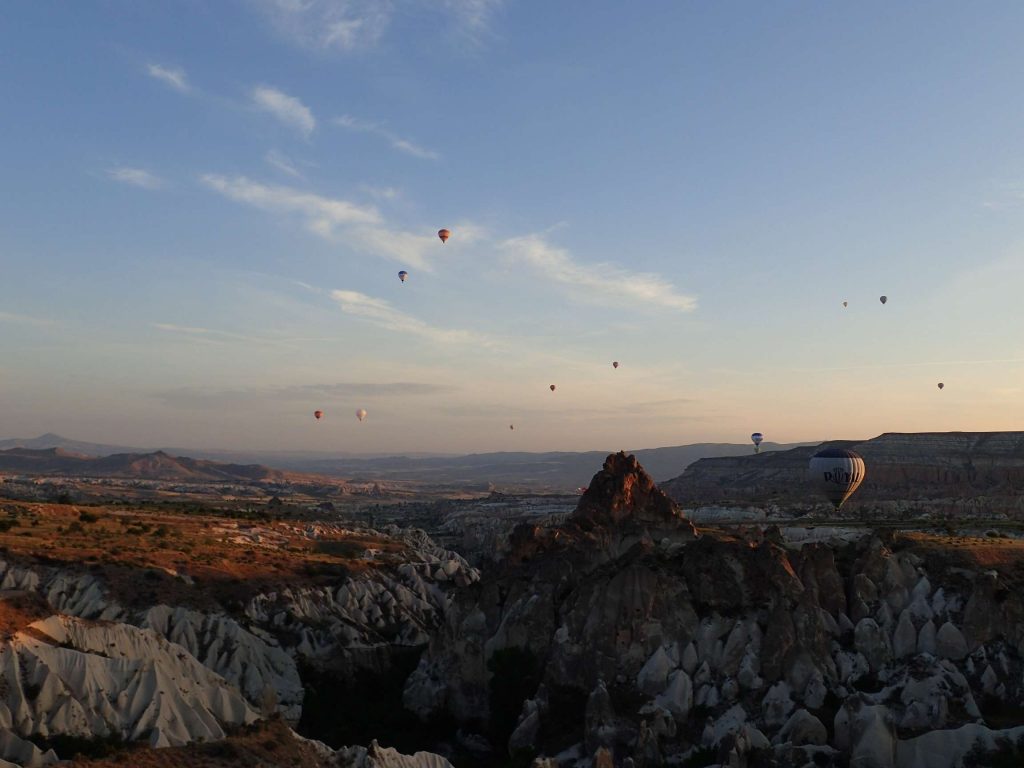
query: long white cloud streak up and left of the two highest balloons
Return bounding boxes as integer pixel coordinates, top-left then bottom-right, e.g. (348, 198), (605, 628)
(201, 173), (380, 231)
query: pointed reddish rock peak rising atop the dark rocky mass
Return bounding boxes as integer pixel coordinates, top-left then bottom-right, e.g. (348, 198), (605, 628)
(569, 451), (691, 528)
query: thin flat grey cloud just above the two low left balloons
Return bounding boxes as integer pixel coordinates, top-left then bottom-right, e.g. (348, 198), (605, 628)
(157, 381), (456, 415)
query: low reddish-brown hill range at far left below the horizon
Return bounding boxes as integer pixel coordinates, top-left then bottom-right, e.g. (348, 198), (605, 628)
(0, 447), (288, 482)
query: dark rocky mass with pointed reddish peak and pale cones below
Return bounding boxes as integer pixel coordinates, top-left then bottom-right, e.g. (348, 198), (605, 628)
(404, 455), (1024, 768)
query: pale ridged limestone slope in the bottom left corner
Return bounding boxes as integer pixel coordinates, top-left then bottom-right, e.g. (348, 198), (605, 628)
(0, 616), (257, 746)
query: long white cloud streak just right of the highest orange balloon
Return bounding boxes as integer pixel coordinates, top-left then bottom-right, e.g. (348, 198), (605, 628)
(501, 234), (696, 312)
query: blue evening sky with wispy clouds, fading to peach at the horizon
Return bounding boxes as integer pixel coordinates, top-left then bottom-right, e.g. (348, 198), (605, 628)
(0, 0), (1024, 453)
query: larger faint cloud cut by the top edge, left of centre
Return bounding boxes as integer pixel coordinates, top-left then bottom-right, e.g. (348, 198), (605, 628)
(256, 0), (394, 53)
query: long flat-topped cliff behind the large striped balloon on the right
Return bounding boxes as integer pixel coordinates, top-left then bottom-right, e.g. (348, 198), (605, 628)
(662, 432), (1024, 517)
